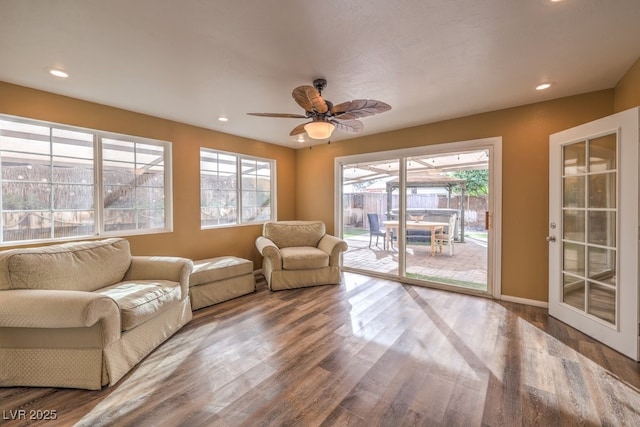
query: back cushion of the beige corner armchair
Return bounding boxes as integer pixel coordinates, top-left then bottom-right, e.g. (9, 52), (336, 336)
(262, 221), (326, 249)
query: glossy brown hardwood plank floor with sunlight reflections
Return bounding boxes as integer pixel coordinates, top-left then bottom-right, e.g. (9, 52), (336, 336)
(0, 273), (640, 426)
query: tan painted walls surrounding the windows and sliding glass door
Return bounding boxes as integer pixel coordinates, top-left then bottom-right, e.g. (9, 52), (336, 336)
(5, 55), (640, 301)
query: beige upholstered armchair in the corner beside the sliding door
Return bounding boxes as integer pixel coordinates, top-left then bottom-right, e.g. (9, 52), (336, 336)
(256, 221), (347, 291)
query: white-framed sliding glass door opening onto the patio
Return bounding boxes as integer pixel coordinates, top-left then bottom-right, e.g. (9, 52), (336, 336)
(336, 140), (499, 293)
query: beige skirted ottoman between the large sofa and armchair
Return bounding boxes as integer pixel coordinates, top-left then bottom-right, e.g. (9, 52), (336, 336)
(189, 256), (256, 310)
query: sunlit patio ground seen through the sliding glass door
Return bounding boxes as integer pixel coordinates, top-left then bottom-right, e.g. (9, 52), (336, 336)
(343, 233), (487, 290)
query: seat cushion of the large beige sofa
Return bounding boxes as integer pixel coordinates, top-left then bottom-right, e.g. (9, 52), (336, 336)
(96, 280), (181, 332)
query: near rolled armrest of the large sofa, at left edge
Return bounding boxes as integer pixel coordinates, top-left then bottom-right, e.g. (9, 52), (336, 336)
(0, 289), (120, 346)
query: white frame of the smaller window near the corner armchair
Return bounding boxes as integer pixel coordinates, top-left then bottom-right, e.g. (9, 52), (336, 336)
(199, 147), (278, 230)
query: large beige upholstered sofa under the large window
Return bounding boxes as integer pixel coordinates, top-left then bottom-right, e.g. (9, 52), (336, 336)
(0, 238), (193, 390)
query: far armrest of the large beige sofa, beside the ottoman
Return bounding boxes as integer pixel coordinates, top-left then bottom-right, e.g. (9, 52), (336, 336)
(123, 256), (193, 298)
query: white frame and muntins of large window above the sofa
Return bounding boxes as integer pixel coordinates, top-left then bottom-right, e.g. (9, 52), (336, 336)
(0, 114), (173, 247)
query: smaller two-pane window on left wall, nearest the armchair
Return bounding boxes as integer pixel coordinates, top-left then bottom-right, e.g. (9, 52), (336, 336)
(200, 148), (275, 228)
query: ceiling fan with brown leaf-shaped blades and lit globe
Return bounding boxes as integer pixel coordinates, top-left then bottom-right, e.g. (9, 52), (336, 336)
(247, 79), (391, 139)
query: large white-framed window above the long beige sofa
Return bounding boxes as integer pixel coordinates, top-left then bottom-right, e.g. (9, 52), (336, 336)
(0, 115), (171, 243)
